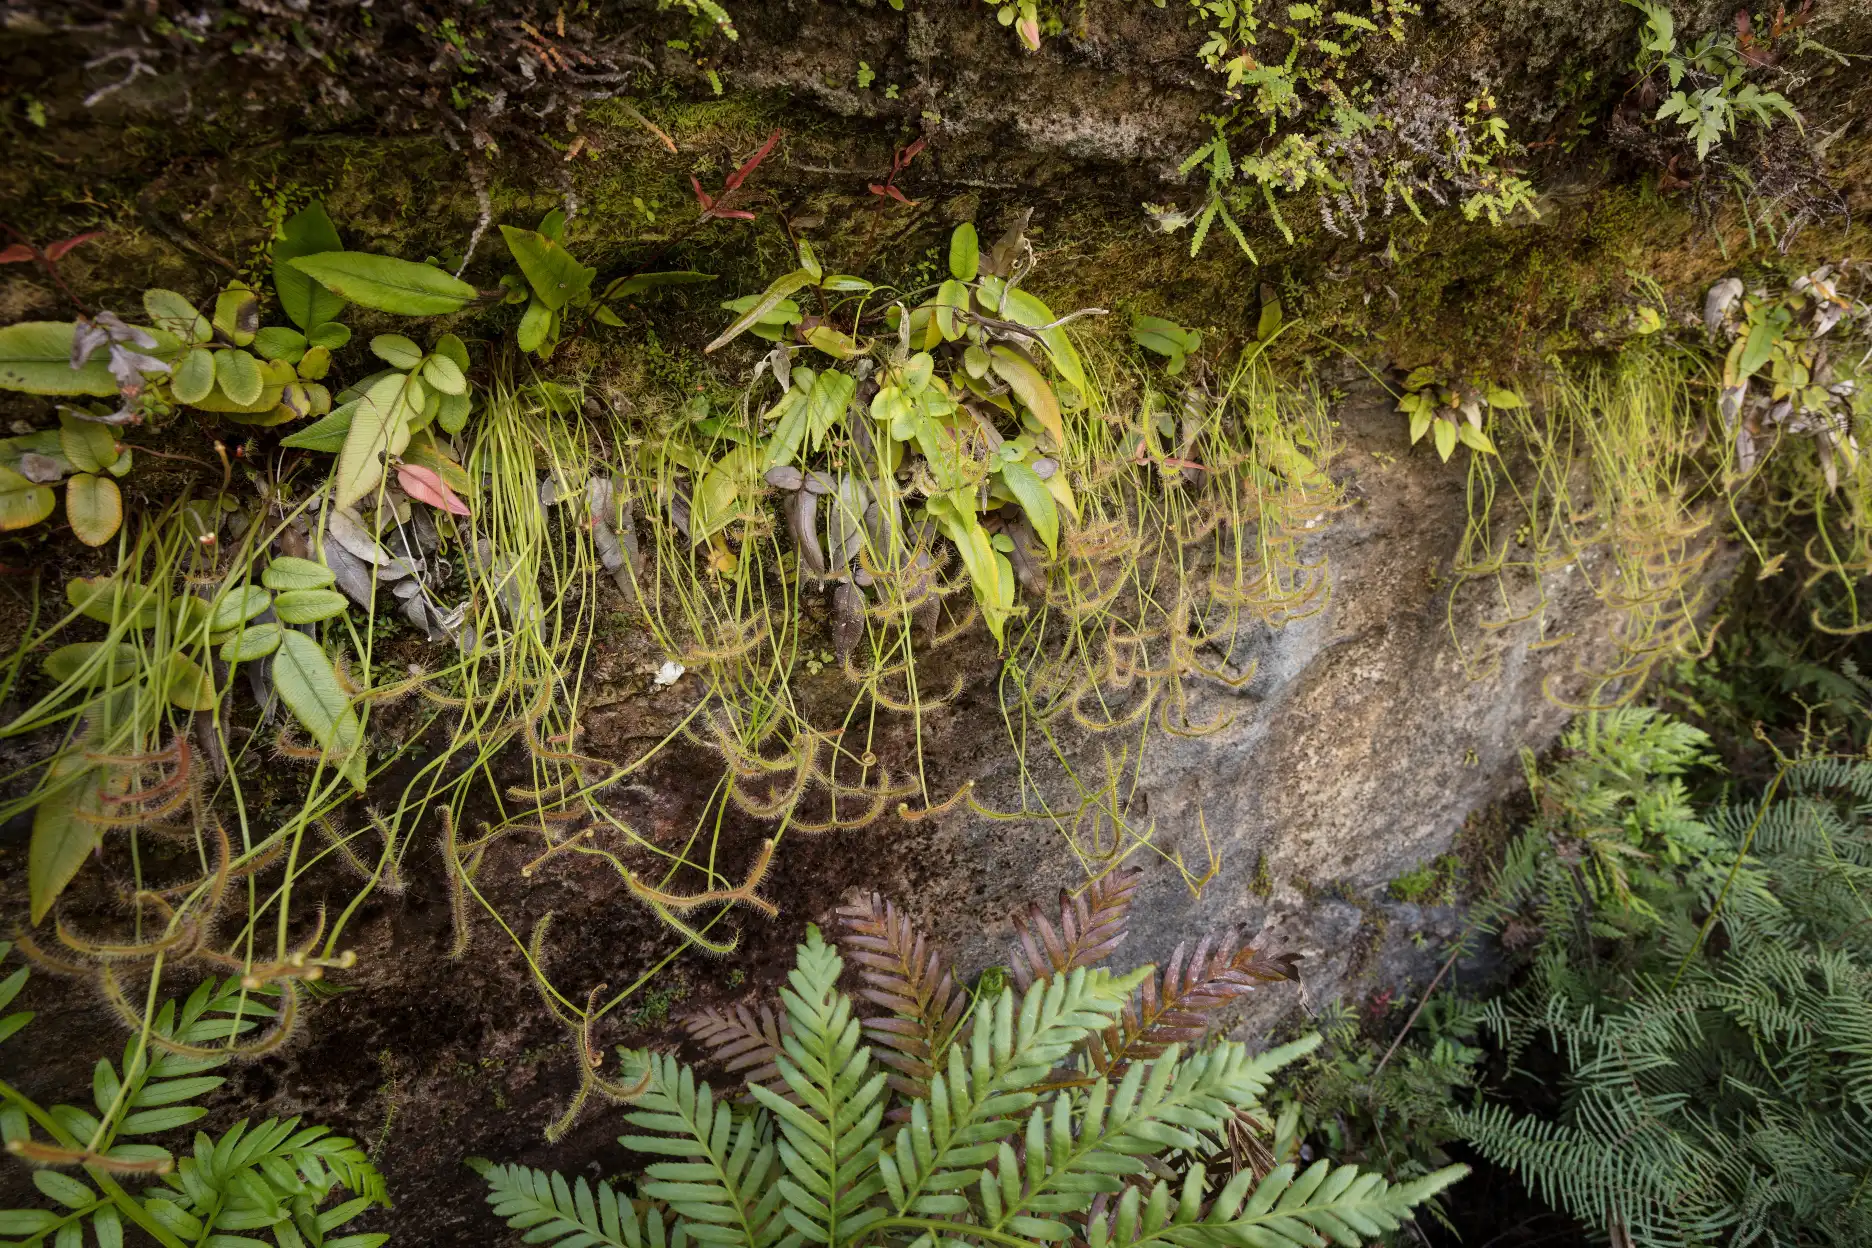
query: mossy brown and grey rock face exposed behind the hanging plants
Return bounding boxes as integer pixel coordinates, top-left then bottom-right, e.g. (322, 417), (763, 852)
(0, 0), (1872, 1248)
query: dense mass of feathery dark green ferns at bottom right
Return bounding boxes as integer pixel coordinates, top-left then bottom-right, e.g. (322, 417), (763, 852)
(1456, 725), (1872, 1248)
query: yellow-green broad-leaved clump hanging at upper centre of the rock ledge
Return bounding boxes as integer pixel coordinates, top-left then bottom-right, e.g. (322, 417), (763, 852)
(673, 223), (1088, 638)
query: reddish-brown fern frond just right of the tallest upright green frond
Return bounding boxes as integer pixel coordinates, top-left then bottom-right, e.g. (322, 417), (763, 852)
(839, 892), (968, 1096)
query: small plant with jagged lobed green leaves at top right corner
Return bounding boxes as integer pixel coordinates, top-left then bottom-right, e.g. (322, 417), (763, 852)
(1625, 0), (1801, 161)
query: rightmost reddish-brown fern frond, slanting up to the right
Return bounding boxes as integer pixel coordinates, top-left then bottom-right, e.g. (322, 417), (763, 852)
(1086, 932), (1299, 1076)
